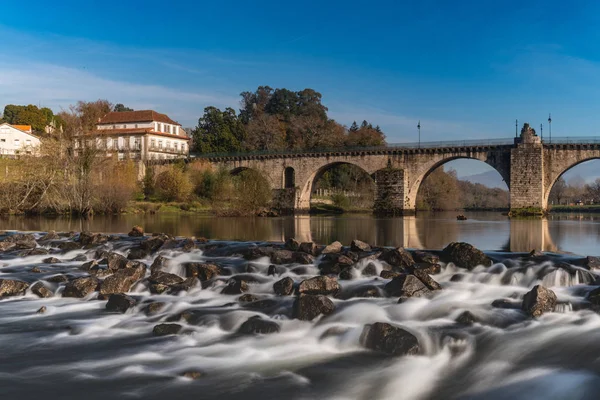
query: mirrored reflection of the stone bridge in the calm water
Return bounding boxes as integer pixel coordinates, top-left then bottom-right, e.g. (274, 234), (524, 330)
(278, 216), (558, 252)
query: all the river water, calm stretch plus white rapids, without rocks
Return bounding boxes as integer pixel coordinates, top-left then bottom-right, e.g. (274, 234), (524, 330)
(0, 214), (600, 399)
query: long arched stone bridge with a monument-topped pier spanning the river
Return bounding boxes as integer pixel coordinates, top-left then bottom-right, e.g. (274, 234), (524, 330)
(189, 128), (600, 214)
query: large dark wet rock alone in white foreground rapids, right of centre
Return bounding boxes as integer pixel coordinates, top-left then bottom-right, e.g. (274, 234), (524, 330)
(364, 322), (421, 356)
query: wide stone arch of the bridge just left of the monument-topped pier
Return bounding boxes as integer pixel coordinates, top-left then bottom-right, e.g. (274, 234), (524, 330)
(405, 153), (510, 210)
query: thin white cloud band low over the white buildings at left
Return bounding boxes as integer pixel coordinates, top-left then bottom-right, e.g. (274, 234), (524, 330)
(0, 62), (239, 125)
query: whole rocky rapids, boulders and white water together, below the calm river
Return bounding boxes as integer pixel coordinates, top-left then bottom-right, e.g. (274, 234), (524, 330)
(0, 233), (600, 400)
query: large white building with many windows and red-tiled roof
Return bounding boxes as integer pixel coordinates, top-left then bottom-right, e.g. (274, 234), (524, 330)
(86, 110), (190, 160)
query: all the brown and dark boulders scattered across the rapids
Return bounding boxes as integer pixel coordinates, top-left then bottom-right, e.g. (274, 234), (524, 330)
(0, 230), (600, 355)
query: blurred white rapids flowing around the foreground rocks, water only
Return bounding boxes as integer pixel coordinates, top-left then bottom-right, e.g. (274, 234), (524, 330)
(0, 234), (600, 400)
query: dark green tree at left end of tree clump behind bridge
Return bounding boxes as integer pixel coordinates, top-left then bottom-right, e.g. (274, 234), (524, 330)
(192, 107), (246, 153)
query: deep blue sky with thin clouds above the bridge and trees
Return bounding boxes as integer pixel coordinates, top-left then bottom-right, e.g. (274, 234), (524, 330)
(0, 0), (600, 178)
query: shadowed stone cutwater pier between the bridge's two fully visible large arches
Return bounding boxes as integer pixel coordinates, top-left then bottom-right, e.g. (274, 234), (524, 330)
(373, 168), (415, 215)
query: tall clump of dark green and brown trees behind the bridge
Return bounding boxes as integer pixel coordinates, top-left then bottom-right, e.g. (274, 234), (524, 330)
(192, 86), (385, 153)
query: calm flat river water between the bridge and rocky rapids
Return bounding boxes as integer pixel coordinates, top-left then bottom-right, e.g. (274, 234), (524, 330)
(0, 212), (600, 255)
